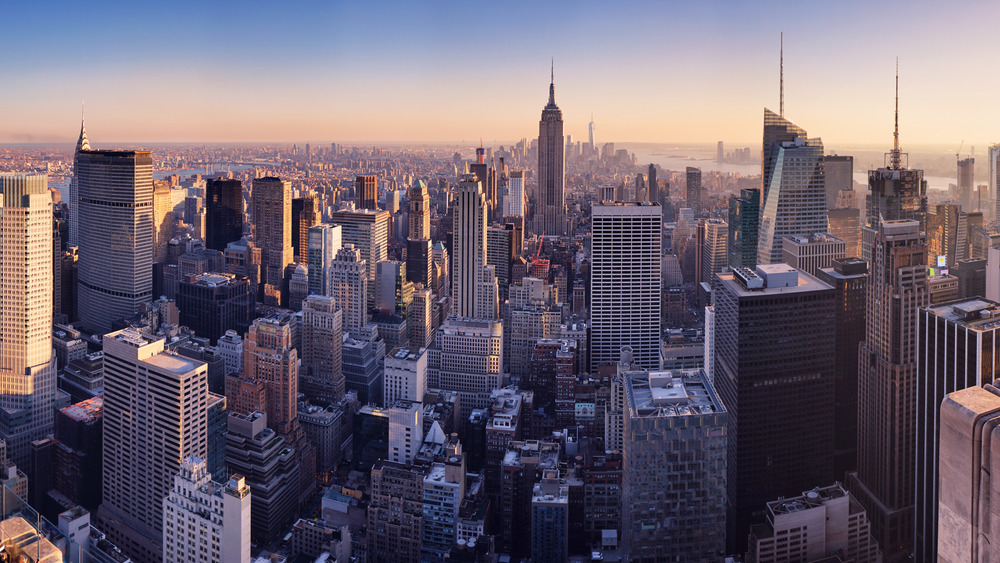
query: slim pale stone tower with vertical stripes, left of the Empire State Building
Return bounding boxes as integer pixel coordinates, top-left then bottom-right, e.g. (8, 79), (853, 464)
(451, 176), (499, 319)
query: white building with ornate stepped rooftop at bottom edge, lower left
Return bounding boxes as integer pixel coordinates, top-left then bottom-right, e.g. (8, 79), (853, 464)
(163, 457), (250, 563)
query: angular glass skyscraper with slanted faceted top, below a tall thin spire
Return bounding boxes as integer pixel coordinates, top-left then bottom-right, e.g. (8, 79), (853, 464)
(757, 109), (827, 264)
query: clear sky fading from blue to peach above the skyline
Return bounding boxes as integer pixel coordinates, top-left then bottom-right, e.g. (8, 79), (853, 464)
(0, 0), (1000, 149)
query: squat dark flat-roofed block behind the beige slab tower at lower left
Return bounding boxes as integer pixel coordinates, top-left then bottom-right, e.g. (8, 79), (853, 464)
(177, 272), (254, 342)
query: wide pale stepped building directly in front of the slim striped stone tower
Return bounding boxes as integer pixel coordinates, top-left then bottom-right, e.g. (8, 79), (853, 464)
(427, 317), (504, 419)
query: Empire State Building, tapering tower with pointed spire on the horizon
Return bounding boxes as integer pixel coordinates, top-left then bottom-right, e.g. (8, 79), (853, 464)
(535, 65), (566, 235)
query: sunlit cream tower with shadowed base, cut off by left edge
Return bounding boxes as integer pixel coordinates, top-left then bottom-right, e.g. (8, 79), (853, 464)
(0, 174), (56, 468)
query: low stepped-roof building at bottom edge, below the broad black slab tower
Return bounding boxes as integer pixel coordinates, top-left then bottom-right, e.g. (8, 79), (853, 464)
(746, 484), (882, 563)
